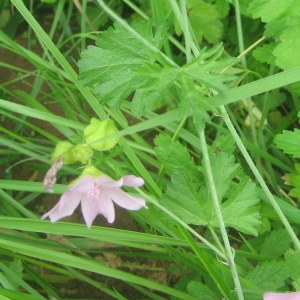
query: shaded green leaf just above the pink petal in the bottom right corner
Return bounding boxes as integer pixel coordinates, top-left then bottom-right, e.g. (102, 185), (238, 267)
(246, 260), (289, 291)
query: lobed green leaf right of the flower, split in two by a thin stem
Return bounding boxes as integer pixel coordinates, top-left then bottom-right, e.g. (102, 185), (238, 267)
(156, 137), (260, 235)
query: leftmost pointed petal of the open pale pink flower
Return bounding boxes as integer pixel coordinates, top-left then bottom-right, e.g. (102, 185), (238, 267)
(42, 190), (83, 223)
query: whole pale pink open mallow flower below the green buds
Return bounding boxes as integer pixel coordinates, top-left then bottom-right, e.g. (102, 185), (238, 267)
(42, 175), (147, 227)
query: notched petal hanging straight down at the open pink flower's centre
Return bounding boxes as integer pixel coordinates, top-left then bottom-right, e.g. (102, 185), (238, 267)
(81, 190), (115, 227)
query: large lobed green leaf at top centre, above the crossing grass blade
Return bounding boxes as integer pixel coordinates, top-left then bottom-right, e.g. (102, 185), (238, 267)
(79, 22), (236, 116)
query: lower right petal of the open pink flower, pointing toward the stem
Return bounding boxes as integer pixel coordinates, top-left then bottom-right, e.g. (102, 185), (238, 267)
(107, 188), (147, 210)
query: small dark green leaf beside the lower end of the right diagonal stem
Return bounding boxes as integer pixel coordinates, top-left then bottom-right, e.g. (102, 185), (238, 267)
(260, 229), (291, 257)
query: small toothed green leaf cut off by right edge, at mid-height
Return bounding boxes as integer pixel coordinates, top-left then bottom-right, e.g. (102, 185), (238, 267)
(274, 128), (300, 158)
